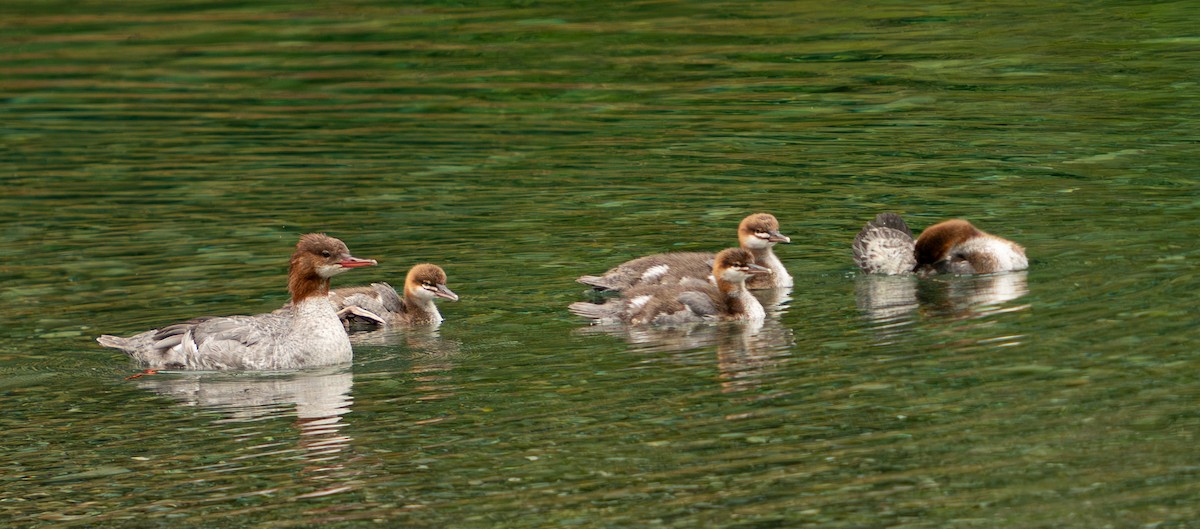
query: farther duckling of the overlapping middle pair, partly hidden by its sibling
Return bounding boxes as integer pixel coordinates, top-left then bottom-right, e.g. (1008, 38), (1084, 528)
(576, 214), (792, 291)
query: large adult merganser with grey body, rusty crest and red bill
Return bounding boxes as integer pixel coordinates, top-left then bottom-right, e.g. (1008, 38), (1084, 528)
(96, 234), (376, 369)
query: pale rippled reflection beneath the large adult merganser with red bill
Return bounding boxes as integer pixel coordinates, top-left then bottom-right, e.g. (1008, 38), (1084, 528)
(136, 369), (358, 498)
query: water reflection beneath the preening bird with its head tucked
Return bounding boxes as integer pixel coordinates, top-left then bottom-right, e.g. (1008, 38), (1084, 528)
(854, 271), (1030, 342)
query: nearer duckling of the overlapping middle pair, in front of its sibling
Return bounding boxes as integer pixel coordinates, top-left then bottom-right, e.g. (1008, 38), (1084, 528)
(568, 248), (770, 325)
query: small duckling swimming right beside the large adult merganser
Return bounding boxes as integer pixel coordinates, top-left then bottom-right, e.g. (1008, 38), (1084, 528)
(329, 263), (458, 329)
